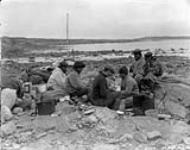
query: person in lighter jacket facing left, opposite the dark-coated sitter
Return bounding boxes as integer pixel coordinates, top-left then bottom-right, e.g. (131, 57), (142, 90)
(116, 66), (139, 112)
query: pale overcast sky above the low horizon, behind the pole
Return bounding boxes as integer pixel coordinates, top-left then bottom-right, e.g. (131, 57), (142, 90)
(0, 0), (190, 39)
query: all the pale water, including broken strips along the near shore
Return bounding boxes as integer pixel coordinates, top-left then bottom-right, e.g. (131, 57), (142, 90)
(1, 40), (190, 63)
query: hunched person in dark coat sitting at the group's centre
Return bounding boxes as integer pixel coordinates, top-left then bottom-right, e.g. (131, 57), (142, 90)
(89, 66), (119, 109)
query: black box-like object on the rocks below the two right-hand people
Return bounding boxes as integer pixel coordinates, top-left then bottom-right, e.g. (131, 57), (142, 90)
(133, 95), (154, 115)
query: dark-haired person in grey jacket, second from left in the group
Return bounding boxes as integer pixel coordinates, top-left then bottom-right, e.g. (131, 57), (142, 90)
(65, 61), (88, 97)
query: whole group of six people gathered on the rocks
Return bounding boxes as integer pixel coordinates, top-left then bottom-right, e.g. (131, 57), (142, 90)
(47, 50), (162, 115)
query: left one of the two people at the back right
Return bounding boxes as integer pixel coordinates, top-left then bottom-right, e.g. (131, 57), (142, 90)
(130, 49), (145, 84)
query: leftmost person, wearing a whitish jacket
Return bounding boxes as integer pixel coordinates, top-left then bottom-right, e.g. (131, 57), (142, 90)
(47, 61), (68, 90)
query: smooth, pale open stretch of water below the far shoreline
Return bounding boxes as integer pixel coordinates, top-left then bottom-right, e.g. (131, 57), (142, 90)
(70, 40), (190, 51)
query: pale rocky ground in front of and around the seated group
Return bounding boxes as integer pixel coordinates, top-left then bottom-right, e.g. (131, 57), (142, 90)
(1, 57), (190, 150)
